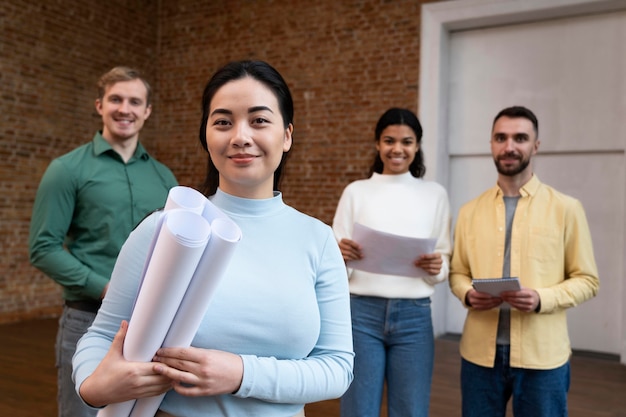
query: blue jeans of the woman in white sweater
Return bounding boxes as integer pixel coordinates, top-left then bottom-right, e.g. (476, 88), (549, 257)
(340, 295), (435, 417)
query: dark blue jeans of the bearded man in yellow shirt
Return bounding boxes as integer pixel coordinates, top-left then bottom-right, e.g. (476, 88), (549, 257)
(461, 346), (570, 417)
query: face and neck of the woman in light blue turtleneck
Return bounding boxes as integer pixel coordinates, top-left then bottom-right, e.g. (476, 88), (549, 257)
(206, 77), (293, 198)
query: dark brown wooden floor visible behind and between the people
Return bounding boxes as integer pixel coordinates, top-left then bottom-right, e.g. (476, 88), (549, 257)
(0, 319), (626, 417)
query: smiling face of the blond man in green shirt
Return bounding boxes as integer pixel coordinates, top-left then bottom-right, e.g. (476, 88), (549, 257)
(96, 79), (152, 144)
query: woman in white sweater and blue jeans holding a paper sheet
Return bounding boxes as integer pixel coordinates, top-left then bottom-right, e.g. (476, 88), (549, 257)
(333, 108), (450, 417)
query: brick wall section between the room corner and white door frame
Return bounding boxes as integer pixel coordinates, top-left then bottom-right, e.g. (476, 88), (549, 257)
(158, 0), (438, 223)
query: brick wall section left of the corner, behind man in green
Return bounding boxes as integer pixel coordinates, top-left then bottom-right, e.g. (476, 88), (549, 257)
(0, 0), (158, 322)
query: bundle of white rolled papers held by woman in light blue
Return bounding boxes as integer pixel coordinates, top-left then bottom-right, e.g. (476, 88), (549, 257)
(98, 186), (241, 417)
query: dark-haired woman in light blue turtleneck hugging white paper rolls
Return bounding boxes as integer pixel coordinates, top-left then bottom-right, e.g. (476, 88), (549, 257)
(74, 61), (354, 417)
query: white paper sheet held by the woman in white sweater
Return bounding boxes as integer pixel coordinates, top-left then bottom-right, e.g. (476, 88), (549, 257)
(346, 223), (437, 278)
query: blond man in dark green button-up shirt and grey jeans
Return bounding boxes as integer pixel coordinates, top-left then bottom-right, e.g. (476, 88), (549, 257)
(29, 67), (177, 417)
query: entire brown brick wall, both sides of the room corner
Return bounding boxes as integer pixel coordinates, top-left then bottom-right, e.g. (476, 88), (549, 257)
(0, 0), (444, 323)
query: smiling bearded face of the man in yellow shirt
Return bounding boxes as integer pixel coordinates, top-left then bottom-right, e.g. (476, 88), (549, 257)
(491, 116), (539, 182)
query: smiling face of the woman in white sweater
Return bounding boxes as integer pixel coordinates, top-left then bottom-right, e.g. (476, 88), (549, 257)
(376, 125), (419, 175)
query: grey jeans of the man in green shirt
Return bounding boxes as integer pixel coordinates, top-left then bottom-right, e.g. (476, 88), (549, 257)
(56, 306), (98, 417)
